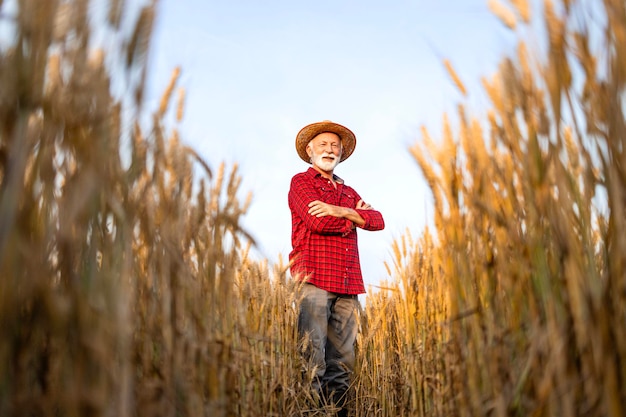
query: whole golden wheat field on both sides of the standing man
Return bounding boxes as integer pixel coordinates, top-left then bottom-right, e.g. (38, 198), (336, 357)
(0, 0), (626, 417)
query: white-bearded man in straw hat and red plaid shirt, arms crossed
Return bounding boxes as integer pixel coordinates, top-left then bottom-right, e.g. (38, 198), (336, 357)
(288, 121), (385, 415)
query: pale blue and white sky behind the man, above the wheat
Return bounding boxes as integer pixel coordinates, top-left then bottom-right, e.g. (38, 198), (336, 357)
(148, 0), (516, 291)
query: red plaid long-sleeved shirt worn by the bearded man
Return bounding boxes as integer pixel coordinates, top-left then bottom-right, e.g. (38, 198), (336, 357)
(289, 167), (385, 294)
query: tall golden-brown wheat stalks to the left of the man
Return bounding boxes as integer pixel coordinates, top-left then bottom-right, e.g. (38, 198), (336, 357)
(0, 0), (307, 416)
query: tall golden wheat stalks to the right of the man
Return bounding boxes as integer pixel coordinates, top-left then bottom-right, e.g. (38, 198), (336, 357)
(363, 1), (626, 416)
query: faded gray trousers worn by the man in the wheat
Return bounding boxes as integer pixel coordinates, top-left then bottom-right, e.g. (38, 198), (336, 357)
(298, 284), (359, 406)
